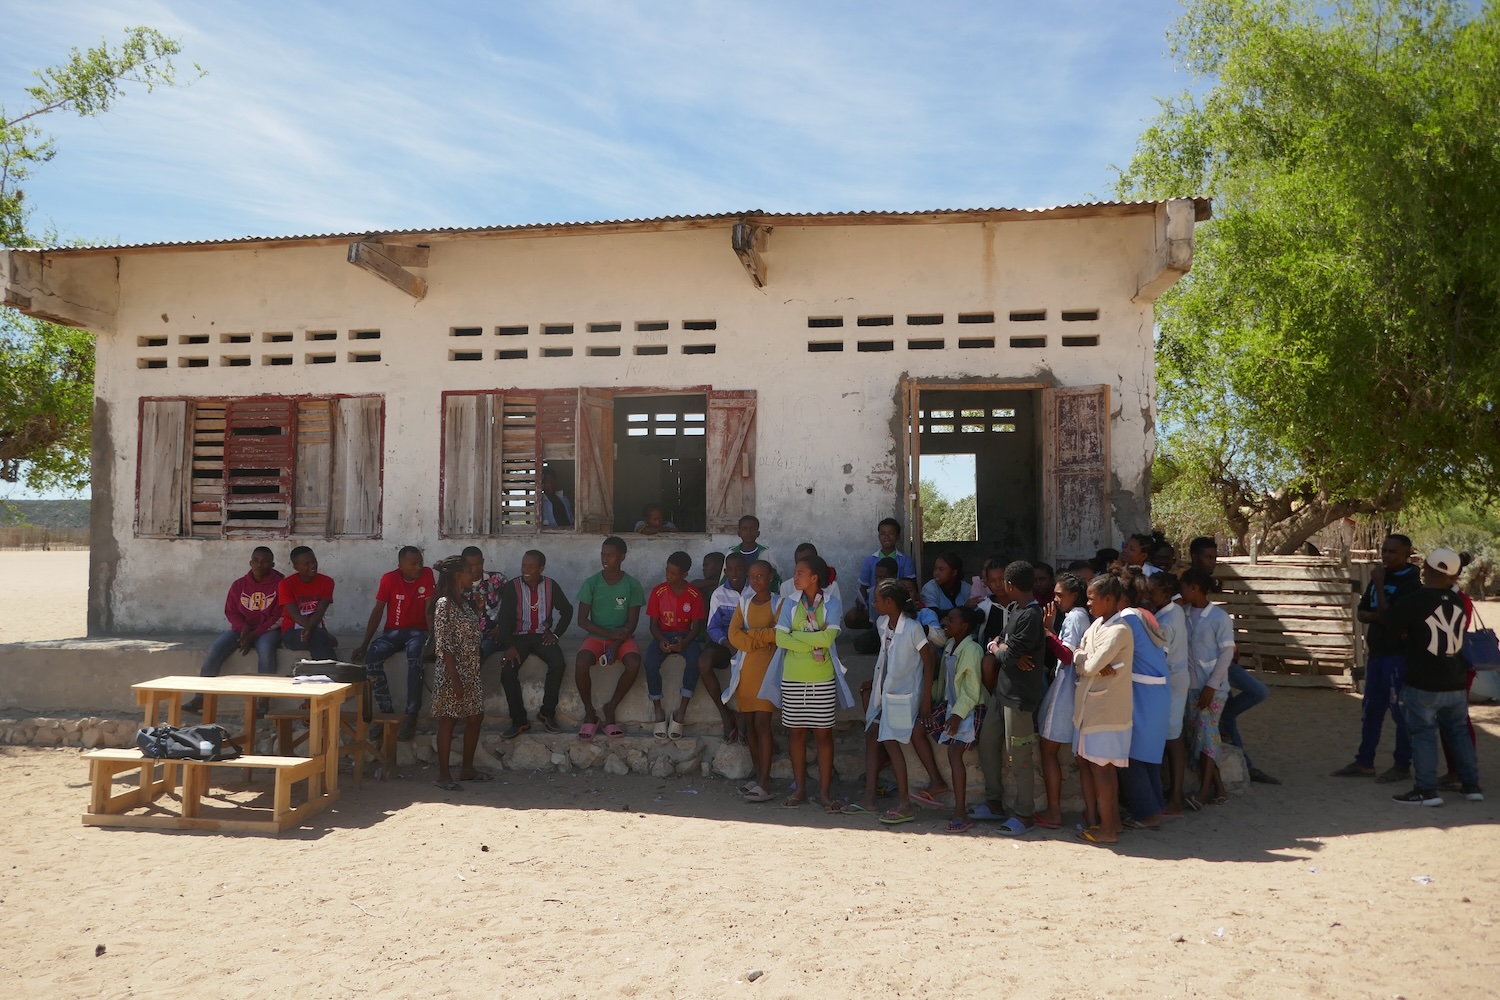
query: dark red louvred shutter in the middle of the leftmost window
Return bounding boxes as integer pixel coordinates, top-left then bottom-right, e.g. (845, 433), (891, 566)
(224, 396), (296, 538)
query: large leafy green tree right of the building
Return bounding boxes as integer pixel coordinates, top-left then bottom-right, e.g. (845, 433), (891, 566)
(1118, 0), (1500, 552)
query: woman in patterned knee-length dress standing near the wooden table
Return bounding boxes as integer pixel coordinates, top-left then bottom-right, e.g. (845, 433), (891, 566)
(432, 556), (495, 792)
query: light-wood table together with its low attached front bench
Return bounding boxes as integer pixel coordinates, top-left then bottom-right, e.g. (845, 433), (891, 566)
(84, 673), (363, 832)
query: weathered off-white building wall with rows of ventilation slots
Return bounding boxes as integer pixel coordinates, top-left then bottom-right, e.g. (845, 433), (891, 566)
(93, 214), (1154, 632)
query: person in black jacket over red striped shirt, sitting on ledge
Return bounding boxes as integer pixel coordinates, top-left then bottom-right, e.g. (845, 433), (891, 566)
(494, 549), (573, 739)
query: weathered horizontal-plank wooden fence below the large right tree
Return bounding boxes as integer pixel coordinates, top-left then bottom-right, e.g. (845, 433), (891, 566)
(1215, 556), (1370, 675)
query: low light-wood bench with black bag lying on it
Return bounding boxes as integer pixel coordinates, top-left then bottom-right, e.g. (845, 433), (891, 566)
(83, 750), (338, 834)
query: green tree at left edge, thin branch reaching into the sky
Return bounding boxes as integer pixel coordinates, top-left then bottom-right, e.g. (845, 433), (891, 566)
(0, 27), (203, 489)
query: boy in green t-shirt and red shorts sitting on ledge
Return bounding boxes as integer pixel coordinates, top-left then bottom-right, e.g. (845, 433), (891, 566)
(573, 535), (647, 741)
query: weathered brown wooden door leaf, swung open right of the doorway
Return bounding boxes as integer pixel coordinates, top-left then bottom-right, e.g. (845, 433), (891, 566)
(1041, 385), (1113, 565)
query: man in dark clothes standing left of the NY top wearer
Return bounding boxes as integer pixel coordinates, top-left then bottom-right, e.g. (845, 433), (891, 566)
(1334, 535), (1422, 783)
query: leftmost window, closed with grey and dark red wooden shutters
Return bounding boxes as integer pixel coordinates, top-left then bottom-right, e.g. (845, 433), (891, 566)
(137, 396), (384, 538)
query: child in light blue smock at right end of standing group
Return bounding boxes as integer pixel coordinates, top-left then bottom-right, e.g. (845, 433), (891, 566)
(1181, 568), (1235, 811)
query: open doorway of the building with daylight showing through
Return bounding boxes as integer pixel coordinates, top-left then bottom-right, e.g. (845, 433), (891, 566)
(909, 388), (1041, 579)
